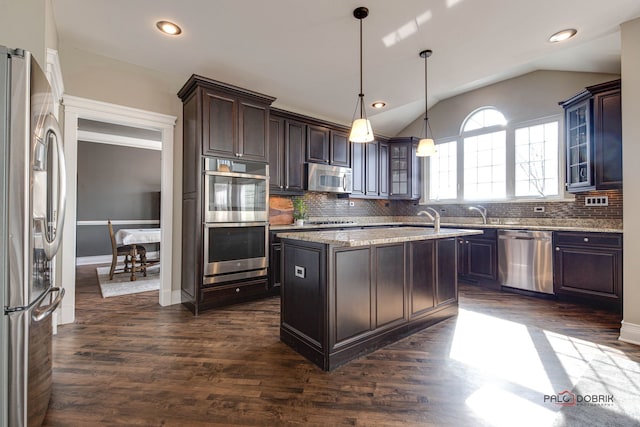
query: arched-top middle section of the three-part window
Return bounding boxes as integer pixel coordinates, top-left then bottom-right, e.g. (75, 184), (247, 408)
(461, 107), (507, 200)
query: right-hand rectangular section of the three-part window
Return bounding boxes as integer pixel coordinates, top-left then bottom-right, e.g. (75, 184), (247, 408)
(515, 122), (558, 197)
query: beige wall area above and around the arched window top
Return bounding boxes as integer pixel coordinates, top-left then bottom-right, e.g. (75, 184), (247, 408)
(399, 71), (620, 139)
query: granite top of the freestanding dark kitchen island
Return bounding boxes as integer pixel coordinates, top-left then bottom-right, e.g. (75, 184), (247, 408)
(278, 224), (482, 246)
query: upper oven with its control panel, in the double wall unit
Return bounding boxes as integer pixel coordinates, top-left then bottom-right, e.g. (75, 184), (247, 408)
(204, 158), (269, 223)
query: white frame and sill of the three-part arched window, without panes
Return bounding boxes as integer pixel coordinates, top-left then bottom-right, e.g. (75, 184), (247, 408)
(419, 110), (575, 205)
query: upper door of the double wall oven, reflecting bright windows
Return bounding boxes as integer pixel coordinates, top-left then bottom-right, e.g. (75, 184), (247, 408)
(204, 171), (269, 223)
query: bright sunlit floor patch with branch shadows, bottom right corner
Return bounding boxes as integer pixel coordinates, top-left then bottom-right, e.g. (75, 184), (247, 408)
(554, 354), (640, 427)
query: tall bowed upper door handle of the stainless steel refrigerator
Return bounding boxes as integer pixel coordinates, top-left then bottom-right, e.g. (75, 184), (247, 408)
(40, 113), (67, 260)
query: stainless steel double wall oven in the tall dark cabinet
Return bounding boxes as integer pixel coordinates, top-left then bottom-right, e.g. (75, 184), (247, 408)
(203, 157), (269, 285)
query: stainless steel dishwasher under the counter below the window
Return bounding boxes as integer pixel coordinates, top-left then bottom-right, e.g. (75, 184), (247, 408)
(498, 230), (553, 294)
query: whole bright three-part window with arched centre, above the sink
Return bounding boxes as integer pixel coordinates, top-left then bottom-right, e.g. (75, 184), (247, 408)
(423, 107), (564, 202)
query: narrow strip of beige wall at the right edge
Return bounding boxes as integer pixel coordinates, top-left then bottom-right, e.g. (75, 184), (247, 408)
(620, 19), (640, 344)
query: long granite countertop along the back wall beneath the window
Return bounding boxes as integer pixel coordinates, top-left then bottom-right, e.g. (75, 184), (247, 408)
(270, 221), (622, 233)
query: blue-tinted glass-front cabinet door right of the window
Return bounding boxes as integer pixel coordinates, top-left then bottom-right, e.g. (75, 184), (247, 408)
(566, 101), (591, 189)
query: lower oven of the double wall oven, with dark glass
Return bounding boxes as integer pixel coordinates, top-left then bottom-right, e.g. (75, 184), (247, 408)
(204, 222), (269, 284)
